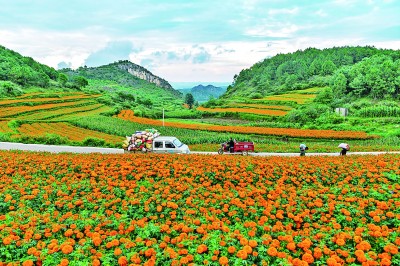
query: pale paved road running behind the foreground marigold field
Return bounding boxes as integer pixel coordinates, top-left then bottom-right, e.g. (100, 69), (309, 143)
(0, 142), (400, 156)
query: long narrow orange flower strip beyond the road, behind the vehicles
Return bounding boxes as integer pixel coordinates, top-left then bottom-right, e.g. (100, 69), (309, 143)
(116, 110), (376, 139)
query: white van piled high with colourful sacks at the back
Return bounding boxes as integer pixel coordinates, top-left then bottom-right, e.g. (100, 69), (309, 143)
(123, 129), (190, 154)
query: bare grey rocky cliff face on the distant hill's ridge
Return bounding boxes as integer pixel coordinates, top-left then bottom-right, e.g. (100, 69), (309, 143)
(114, 61), (174, 90)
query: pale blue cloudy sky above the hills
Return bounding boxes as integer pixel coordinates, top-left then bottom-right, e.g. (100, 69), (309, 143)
(0, 0), (400, 84)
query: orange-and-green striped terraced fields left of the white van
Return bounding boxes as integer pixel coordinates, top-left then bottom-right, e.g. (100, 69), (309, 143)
(0, 92), (122, 145)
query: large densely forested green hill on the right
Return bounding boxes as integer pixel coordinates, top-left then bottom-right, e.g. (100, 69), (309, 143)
(222, 46), (400, 99)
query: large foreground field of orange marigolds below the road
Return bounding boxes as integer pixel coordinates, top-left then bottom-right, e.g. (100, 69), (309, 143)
(0, 151), (400, 265)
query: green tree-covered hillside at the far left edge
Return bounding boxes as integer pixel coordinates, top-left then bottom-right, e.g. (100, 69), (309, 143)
(0, 45), (59, 87)
